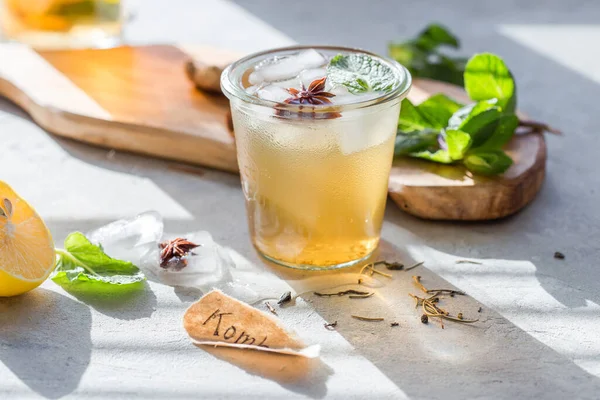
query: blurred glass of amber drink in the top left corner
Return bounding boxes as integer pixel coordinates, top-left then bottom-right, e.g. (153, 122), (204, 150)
(0, 0), (122, 48)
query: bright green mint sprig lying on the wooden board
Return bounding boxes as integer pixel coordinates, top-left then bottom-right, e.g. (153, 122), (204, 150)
(395, 53), (519, 175)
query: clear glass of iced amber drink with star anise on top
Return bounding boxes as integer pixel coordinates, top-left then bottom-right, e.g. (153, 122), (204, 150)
(221, 46), (411, 269)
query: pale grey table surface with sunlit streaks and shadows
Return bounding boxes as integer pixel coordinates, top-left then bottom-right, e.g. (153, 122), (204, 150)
(0, 0), (600, 399)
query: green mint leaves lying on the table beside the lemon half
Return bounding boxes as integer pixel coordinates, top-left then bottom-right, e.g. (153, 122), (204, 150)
(52, 232), (145, 291)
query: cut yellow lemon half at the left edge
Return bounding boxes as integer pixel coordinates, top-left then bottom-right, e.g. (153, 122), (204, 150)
(0, 181), (56, 297)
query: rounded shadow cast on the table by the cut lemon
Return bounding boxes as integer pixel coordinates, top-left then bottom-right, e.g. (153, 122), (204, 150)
(0, 289), (92, 399)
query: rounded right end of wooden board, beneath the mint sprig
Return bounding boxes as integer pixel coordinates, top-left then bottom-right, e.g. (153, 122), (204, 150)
(389, 79), (546, 221)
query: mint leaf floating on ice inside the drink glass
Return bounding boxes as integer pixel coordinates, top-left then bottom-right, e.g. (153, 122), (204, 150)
(327, 53), (397, 94)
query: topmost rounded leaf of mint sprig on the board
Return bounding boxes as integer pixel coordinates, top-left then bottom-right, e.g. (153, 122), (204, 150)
(464, 53), (517, 113)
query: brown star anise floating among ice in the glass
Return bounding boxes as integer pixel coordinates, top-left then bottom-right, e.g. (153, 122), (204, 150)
(277, 77), (341, 119)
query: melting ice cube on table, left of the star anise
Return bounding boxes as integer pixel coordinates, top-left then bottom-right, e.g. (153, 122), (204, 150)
(86, 211), (163, 265)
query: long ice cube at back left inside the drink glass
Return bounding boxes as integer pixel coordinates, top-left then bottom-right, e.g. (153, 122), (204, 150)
(248, 49), (327, 85)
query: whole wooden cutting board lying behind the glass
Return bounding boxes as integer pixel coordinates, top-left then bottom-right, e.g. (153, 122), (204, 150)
(0, 44), (546, 220)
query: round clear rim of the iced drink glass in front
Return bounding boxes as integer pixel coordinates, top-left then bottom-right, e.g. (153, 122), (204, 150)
(221, 45), (412, 113)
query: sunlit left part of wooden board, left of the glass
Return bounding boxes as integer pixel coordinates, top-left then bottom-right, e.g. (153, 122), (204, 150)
(0, 45), (238, 172)
